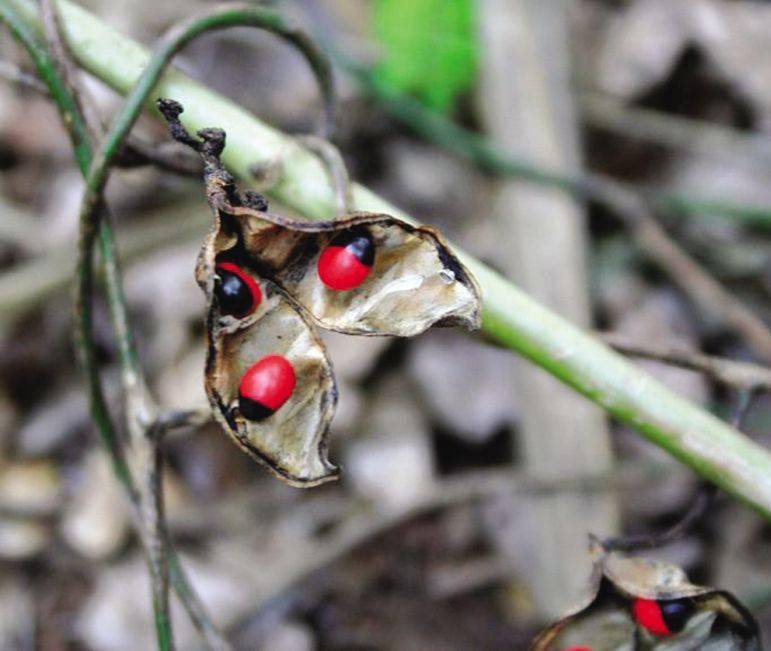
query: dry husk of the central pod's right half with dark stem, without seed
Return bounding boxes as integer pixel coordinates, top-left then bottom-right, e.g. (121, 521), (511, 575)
(178, 117), (482, 337)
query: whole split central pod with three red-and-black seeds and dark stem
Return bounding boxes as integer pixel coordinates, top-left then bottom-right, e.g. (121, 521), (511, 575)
(158, 100), (481, 486)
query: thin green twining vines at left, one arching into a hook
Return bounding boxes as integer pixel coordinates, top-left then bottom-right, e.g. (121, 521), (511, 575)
(0, 4), (334, 650)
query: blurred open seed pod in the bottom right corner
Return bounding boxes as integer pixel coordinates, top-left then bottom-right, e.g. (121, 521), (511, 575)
(532, 546), (761, 651)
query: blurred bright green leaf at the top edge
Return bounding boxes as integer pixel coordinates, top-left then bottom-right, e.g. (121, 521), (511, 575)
(374, 0), (477, 111)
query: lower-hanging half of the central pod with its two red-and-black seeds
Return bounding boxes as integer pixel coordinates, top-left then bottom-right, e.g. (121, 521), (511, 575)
(196, 220), (337, 486)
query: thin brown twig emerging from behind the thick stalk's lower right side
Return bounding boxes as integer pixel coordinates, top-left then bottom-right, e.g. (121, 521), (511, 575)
(597, 332), (771, 391)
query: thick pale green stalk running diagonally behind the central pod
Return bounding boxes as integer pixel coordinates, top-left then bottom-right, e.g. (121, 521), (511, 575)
(7, 0), (771, 518)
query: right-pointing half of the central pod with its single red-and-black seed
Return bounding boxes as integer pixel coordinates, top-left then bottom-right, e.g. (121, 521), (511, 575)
(217, 209), (480, 337)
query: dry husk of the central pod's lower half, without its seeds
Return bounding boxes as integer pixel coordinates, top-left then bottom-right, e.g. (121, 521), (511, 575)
(196, 211), (338, 487)
